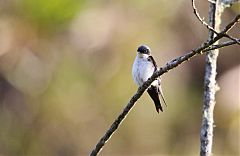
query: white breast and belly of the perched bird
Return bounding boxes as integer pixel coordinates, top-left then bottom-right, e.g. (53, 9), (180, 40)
(132, 54), (154, 86)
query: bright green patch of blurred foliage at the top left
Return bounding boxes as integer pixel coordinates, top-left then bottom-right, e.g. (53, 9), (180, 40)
(19, 0), (84, 33)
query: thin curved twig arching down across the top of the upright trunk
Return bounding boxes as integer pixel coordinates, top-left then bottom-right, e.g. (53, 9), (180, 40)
(192, 0), (240, 45)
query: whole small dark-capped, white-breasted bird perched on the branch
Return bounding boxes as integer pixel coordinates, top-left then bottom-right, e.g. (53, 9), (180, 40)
(132, 45), (166, 113)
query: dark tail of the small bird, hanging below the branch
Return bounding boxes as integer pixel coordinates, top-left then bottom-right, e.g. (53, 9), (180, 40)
(147, 86), (163, 113)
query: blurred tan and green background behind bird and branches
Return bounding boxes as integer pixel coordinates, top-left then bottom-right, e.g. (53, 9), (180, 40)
(0, 0), (240, 156)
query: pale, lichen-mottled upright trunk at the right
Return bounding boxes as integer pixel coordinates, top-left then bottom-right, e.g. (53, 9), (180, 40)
(200, 0), (224, 156)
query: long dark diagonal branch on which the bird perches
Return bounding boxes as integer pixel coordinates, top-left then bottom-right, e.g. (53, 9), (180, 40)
(90, 16), (240, 156)
